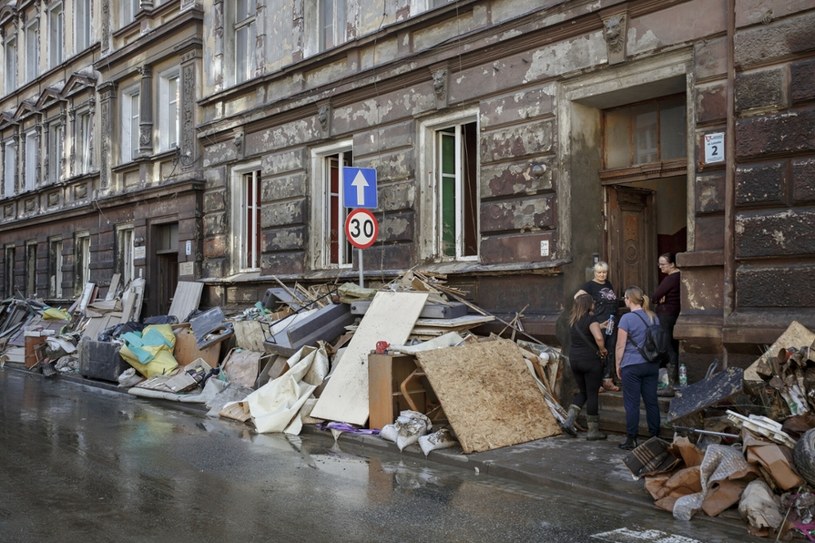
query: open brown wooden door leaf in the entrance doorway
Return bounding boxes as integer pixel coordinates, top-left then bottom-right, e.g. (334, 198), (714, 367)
(606, 185), (657, 297)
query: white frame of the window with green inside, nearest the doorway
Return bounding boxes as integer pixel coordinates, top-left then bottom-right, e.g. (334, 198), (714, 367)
(419, 108), (482, 261)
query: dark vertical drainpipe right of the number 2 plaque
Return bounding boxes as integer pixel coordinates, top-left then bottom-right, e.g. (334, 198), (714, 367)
(722, 0), (736, 369)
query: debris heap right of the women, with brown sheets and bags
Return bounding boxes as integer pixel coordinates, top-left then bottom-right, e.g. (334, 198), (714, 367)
(624, 322), (815, 541)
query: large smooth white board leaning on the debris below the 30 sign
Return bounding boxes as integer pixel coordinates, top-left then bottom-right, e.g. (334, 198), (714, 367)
(311, 292), (427, 425)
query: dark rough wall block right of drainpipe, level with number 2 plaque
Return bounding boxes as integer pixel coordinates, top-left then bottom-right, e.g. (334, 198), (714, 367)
(736, 110), (815, 158)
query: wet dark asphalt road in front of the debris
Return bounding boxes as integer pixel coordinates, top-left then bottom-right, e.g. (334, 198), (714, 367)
(0, 368), (764, 543)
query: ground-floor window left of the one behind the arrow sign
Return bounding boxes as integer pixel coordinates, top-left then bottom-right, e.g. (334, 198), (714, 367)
(232, 164), (262, 271)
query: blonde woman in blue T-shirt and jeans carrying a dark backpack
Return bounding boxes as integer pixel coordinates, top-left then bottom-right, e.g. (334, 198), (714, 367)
(616, 287), (659, 451)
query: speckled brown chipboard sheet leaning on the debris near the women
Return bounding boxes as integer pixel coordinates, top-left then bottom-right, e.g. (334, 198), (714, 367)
(416, 340), (560, 453)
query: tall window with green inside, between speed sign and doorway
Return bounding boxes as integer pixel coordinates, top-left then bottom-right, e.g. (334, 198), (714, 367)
(420, 112), (480, 260)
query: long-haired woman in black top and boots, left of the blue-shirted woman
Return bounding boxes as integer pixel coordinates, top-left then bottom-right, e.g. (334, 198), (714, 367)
(563, 294), (608, 441)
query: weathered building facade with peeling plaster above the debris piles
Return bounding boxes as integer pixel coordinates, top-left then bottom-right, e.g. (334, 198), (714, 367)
(0, 0), (815, 377)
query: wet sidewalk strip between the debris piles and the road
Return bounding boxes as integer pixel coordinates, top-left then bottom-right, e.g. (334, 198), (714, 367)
(15, 364), (746, 533)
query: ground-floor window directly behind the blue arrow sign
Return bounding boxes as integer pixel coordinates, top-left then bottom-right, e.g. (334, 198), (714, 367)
(311, 141), (353, 268)
